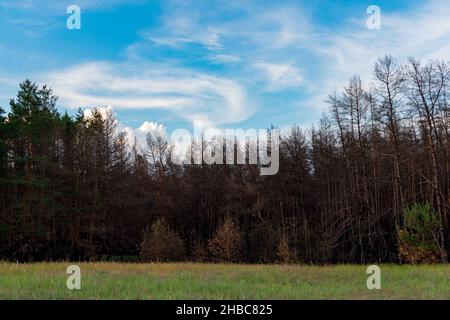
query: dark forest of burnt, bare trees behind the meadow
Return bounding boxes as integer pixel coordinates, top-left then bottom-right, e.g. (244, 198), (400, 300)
(0, 56), (450, 264)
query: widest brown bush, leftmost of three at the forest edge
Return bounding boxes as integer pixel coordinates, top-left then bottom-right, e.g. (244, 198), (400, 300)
(140, 218), (185, 262)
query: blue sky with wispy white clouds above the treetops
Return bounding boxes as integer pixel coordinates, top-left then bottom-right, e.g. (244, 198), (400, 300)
(0, 0), (450, 139)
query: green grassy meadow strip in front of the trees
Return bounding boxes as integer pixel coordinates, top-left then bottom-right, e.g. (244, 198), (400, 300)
(0, 263), (450, 299)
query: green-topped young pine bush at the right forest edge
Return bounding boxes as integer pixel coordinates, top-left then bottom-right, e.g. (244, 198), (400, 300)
(397, 203), (440, 264)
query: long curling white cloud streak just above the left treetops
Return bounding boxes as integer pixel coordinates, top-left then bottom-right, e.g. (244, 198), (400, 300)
(43, 62), (252, 124)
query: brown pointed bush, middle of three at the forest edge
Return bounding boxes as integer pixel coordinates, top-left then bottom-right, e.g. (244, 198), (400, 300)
(208, 218), (242, 262)
